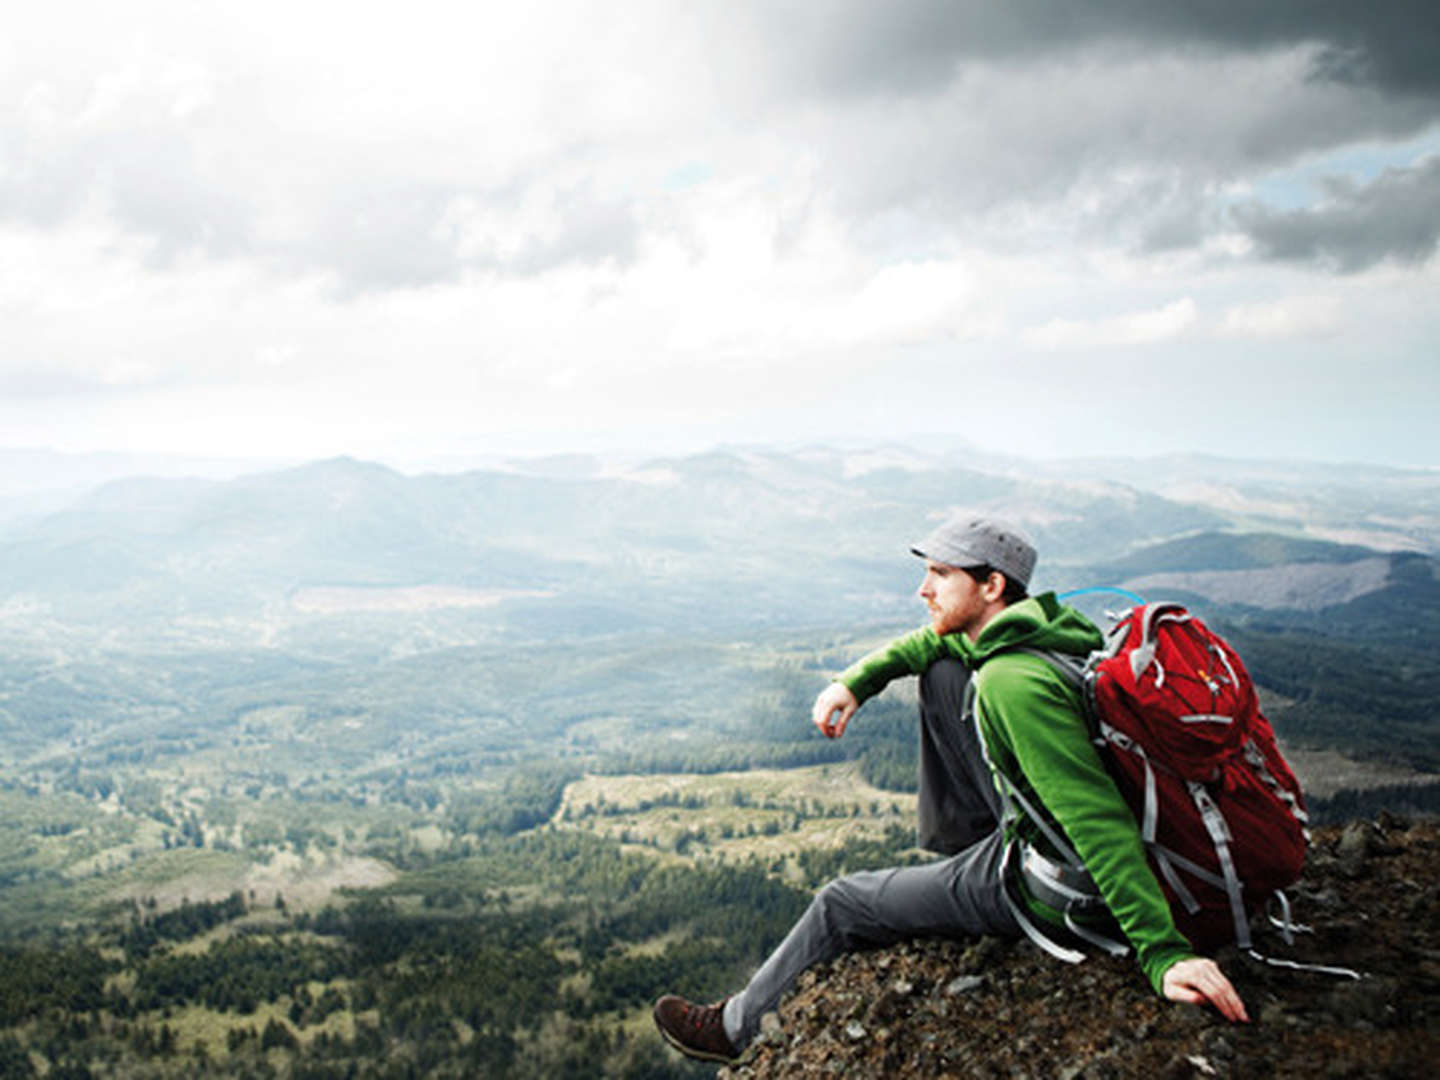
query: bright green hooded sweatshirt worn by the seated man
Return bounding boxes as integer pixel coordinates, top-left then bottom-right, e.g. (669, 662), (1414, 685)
(838, 593), (1195, 992)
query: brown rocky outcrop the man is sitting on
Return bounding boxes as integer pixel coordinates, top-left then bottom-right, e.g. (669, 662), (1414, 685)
(720, 815), (1440, 1080)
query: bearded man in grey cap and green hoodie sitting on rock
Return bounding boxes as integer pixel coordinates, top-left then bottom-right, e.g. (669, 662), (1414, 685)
(654, 518), (1248, 1061)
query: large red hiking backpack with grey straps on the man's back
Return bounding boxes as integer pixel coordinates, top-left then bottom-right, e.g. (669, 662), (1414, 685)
(1057, 603), (1309, 950)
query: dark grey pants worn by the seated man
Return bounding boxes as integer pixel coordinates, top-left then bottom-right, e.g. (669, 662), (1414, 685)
(724, 660), (1021, 1047)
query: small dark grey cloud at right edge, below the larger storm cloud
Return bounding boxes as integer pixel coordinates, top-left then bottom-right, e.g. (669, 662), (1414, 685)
(1234, 157), (1440, 274)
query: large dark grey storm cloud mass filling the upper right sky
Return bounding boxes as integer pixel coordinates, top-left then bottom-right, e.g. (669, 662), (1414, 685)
(731, 0), (1440, 266)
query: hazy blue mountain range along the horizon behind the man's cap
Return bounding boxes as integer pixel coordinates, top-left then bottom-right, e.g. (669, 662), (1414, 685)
(0, 446), (1440, 632)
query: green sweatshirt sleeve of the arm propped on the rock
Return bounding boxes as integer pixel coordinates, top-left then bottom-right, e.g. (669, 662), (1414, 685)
(976, 655), (1195, 992)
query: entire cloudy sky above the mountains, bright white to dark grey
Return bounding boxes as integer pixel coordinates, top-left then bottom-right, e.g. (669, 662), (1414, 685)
(0, 0), (1440, 467)
